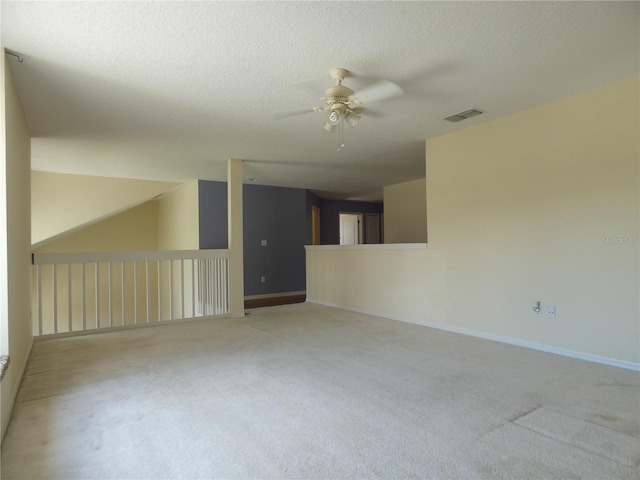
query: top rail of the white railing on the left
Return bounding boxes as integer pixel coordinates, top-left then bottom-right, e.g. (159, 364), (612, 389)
(32, 249), (229, 265)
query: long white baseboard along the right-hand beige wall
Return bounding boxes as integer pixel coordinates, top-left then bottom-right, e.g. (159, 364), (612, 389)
(307, 297), (640, 372)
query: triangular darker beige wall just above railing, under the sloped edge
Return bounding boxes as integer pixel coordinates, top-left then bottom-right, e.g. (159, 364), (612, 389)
(34, 201), (158, 253)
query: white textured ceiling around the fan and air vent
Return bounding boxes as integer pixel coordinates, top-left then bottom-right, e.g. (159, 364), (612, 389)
(0, 1), (640, 199)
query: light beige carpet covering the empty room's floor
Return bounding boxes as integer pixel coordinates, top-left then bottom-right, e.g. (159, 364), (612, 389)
(2, 304), (640, 480)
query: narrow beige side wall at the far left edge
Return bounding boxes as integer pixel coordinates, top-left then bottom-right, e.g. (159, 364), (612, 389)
(0, 53), (33, 437)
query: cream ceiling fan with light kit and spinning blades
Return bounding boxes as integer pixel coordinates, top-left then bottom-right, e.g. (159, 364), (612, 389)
(277, 68), (404, 150)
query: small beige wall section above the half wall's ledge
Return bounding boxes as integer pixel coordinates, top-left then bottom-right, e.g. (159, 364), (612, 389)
(384, 178), (427, 243)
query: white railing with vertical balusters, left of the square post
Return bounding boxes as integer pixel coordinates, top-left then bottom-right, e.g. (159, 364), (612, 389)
(32, 250), (229, 337)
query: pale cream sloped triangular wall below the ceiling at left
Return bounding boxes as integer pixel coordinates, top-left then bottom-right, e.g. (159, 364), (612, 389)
(31, 171), (179, 247)
